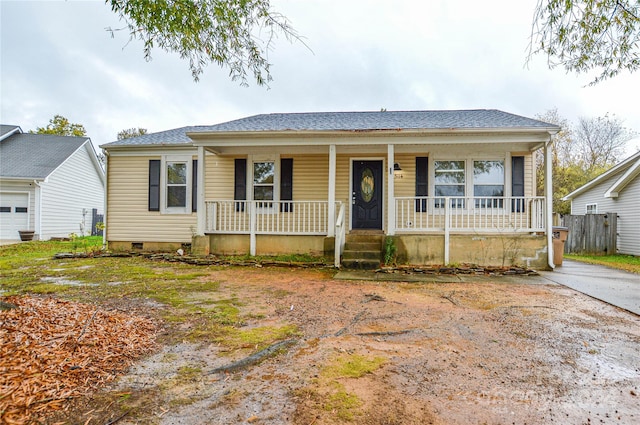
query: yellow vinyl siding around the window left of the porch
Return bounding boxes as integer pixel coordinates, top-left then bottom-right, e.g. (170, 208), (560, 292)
(107, 156), (195, 243)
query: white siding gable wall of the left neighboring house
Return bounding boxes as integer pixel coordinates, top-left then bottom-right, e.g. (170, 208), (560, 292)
(40, 144), (104, 240)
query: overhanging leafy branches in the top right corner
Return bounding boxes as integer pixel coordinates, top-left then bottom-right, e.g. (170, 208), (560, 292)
(529, 0), (640, 84)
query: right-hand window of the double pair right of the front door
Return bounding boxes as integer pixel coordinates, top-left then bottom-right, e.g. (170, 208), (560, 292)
(473, 161), (504, 208)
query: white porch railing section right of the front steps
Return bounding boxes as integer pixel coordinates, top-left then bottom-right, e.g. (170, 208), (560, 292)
(395, 197), (546, 233)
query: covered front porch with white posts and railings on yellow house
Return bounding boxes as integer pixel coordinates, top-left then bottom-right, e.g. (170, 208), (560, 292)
(192, 133), (553, 267)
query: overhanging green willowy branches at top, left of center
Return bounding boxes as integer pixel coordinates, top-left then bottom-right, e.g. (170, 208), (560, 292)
(105, 0), (299, 85)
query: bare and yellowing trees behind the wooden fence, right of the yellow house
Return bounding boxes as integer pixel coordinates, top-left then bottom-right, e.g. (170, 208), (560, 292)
(536, 109), (635, 214)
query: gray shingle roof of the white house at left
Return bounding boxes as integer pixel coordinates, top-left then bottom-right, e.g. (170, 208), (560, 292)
(0, 133), (89, 179)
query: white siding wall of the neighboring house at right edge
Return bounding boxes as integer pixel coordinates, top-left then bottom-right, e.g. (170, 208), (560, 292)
(571, 170), (640, 255)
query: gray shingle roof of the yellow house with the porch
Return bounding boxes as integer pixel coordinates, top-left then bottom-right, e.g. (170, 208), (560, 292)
(104, 109), (558, 147)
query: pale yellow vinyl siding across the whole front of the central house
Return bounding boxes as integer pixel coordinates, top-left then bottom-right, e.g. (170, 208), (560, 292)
(107, 146), (534, 242)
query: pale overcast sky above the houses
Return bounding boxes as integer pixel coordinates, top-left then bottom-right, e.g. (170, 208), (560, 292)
(0, 0), (640, 154)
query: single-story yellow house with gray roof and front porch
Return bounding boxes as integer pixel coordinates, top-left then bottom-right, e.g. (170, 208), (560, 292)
(101, 110), (559, 268)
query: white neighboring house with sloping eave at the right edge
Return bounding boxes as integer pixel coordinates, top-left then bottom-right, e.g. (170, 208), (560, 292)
(562, 152), (640, 255)
